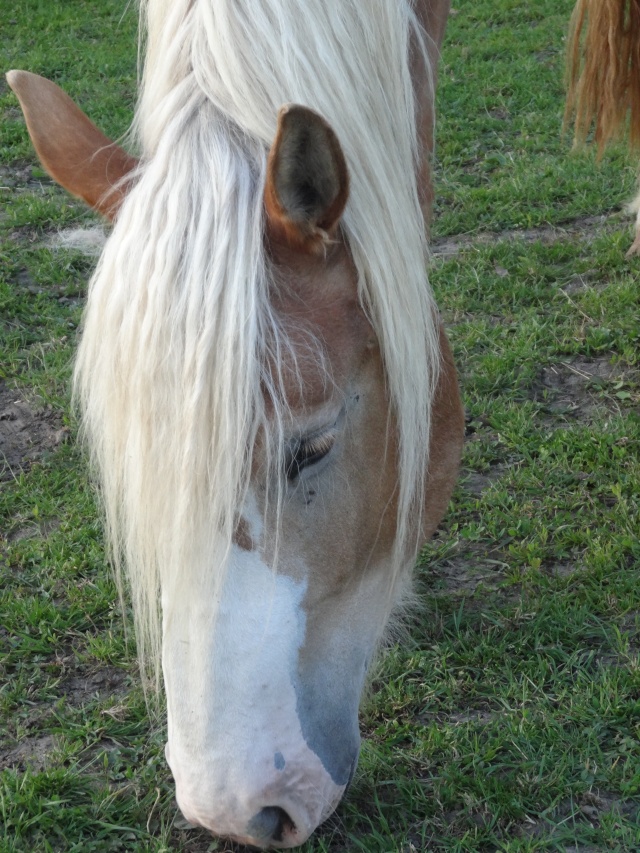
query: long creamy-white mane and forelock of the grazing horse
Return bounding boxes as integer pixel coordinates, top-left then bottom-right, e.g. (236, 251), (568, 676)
(75, 0), (439, 678)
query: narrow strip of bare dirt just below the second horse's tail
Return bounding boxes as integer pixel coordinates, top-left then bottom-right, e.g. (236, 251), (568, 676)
(431, 213), (621, 260)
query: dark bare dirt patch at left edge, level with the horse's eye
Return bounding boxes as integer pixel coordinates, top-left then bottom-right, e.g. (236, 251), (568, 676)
(0, 382), (69, 482)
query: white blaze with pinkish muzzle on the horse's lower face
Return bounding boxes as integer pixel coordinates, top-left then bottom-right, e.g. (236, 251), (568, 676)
(163, 532), (345, 847)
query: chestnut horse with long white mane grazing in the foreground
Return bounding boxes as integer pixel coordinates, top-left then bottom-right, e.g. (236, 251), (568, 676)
(8, 0), (463, 848)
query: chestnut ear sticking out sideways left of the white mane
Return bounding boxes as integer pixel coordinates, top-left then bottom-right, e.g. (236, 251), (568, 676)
(7, 71), (138, 219)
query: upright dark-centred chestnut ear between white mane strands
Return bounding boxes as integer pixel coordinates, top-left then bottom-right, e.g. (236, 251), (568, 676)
(264, 104), (349, 254)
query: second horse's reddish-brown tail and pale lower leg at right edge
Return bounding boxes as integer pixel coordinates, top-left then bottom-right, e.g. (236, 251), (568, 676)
(565, 0), (640, 257)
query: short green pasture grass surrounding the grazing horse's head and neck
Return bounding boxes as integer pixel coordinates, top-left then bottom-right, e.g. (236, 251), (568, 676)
(0, 0), (640, 853)
